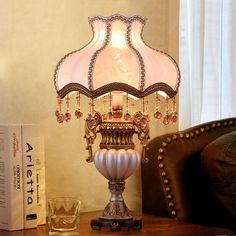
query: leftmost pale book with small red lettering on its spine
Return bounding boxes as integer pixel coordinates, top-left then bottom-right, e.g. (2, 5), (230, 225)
(0, 124), (24, 231)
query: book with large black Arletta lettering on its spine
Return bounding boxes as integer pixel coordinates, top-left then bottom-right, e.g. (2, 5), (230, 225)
(22, 125), (46, 229)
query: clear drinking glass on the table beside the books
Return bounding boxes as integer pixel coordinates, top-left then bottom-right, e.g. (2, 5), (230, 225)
(48, 197), (81, 236)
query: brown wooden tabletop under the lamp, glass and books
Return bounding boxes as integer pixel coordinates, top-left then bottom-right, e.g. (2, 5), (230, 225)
(0, 212), (236, 236)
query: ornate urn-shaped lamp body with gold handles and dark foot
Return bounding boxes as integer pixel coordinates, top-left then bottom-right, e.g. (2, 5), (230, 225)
(86, 117), (147, 231)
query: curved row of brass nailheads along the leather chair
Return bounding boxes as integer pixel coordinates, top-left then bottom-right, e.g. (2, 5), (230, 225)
(157, 118), (236, 218)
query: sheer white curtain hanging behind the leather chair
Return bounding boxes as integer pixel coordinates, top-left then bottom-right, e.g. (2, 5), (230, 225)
(179, 0), (236, 130)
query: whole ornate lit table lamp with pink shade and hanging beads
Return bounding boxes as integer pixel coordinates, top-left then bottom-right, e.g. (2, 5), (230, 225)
(54, 14), (180, 229)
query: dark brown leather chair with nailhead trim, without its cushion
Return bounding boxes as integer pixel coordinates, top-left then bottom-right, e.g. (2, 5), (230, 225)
(141, 118), (236, 230)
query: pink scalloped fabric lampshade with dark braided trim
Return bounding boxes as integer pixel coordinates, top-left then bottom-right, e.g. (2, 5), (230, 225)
(54, 14), (180, 98)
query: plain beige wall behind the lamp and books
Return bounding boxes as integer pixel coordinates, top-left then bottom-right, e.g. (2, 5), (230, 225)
(0, 0), (178, 211)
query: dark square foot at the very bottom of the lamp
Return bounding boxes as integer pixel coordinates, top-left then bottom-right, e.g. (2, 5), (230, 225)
(90, 218), (142, 231)
